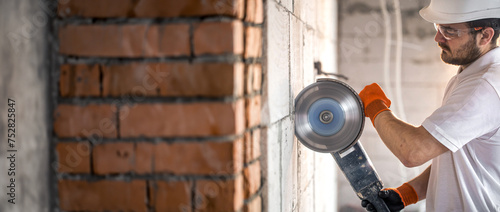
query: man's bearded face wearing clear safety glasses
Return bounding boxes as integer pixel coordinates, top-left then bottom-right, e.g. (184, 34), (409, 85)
(434, 23), (481, 65)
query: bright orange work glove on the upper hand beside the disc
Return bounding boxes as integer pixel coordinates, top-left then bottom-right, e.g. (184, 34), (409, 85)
(359, 83), (391, 126)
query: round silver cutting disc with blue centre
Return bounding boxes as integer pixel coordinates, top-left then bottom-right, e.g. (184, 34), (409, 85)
(295, 79), (365, 152)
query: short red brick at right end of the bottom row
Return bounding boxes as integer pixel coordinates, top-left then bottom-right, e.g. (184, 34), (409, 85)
(195, 175), (243, 212)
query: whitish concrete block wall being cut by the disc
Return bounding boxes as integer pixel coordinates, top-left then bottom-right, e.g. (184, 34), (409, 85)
(261, 0), (337, 212)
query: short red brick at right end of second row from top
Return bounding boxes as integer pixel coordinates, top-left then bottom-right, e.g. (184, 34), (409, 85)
(193, 21), (243, 55)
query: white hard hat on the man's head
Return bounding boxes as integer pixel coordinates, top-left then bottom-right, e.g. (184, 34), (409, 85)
(419, 0), (500, 24)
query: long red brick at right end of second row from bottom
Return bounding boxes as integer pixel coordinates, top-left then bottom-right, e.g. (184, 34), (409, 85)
(154, 139), (243, 175)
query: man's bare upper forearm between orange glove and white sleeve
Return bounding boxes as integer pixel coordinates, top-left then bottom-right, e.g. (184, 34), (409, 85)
(374, 110), (448, 167)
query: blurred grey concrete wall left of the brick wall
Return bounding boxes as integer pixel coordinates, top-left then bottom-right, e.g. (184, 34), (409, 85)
(0, 0), (50, 212)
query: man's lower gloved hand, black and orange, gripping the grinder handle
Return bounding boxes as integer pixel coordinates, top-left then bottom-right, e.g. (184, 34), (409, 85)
(361, 183), (418, 212)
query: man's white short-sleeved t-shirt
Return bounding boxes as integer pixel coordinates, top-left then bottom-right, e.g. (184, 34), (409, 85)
(422, 48), (500, 211)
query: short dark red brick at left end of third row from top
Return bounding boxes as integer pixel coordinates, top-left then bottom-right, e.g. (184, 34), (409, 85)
(59, 64), (101, 97)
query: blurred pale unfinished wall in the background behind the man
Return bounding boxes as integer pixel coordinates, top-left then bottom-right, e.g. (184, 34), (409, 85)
(338, 0), (457, 211)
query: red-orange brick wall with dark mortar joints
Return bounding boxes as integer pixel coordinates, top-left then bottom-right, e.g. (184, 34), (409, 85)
(52, 0), (264, 211)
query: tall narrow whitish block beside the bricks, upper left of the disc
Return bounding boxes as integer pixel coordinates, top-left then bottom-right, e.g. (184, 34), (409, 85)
(266, 1), (291, 123)
